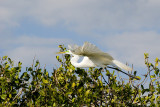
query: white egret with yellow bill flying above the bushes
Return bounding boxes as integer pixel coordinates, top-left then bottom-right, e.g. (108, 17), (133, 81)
(58, 42), (132, 71)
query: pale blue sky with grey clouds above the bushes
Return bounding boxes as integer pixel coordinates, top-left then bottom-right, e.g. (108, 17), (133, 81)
(0, 0), (160, 75)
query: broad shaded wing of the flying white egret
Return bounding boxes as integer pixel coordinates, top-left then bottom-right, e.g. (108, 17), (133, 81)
(69, 42), (113, 66)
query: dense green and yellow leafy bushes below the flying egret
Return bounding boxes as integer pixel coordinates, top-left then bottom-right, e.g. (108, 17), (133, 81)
(0, 46), (160, 107)
